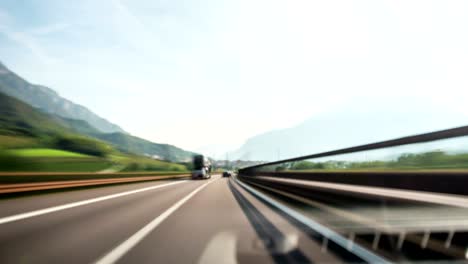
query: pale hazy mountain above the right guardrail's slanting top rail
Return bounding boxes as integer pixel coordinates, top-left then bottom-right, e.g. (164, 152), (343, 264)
(230, 99), (468, 161)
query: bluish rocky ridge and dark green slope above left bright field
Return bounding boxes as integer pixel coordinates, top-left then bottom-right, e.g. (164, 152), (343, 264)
(0, 63), (195, 162)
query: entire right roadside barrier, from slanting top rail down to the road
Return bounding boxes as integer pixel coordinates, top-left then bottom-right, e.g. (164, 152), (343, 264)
(234, 126), (468, 262)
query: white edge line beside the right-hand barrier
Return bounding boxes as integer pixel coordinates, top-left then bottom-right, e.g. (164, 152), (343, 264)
(236, 179), (391, 263)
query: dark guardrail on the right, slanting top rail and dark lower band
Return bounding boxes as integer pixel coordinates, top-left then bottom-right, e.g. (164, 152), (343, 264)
(239, 126), (468, 195)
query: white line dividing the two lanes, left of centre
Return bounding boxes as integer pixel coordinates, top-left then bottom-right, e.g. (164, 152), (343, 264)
(95, 181), (213, 264)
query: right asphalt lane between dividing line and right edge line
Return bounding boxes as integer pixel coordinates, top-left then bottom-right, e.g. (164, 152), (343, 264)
(119, 175), (339, 263)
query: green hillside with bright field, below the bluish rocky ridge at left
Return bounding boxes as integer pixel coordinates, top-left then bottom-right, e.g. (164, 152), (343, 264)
(0, 92), (188, 172)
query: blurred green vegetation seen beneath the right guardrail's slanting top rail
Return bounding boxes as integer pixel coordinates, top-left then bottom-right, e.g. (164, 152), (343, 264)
(284, 151), (468, 171)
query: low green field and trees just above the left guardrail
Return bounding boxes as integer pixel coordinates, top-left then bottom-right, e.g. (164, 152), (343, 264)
(0, 135), (188, 172)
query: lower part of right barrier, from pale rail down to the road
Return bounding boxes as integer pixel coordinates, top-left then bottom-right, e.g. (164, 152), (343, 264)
(240, 176), (468, 263)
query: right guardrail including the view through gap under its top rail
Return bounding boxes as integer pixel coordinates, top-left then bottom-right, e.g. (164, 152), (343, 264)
(239, 126), (468, 195)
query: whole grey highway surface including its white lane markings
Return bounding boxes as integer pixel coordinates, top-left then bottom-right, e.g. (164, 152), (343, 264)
(0, 175), (468, 264)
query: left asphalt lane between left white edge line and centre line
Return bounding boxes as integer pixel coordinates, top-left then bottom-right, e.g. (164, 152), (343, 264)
(0, 178), (202, 263)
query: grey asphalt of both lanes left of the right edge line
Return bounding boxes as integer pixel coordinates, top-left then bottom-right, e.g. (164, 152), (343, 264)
(0, 176), (358, 263)
